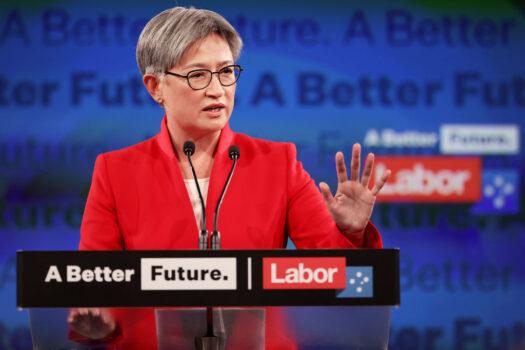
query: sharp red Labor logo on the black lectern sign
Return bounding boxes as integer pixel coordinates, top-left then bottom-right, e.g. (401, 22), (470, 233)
(263, 257), (346, 289)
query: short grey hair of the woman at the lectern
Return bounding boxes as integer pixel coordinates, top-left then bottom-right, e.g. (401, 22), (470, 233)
(136, 7), (242, 75)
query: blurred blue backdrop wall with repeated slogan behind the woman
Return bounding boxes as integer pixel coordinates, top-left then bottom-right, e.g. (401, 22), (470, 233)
(0, 0), (525, 349)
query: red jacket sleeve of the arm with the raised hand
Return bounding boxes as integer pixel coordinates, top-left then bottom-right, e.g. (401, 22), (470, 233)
(286, 144), (383, 248)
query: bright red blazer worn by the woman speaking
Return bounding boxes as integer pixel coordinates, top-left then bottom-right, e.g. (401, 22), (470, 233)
(80, 118), (382, 348)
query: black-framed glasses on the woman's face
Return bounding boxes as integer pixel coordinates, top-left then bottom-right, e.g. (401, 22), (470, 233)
(164, 64), (242, 90)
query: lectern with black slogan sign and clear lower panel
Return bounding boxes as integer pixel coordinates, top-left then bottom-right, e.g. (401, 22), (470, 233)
(17, 249), (400, 350)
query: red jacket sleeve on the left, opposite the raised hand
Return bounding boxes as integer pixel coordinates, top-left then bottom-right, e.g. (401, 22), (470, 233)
(79, 154), (124, 250)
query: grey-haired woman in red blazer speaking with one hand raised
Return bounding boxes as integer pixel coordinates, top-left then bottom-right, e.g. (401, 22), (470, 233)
(69, 7), (389, 348)
